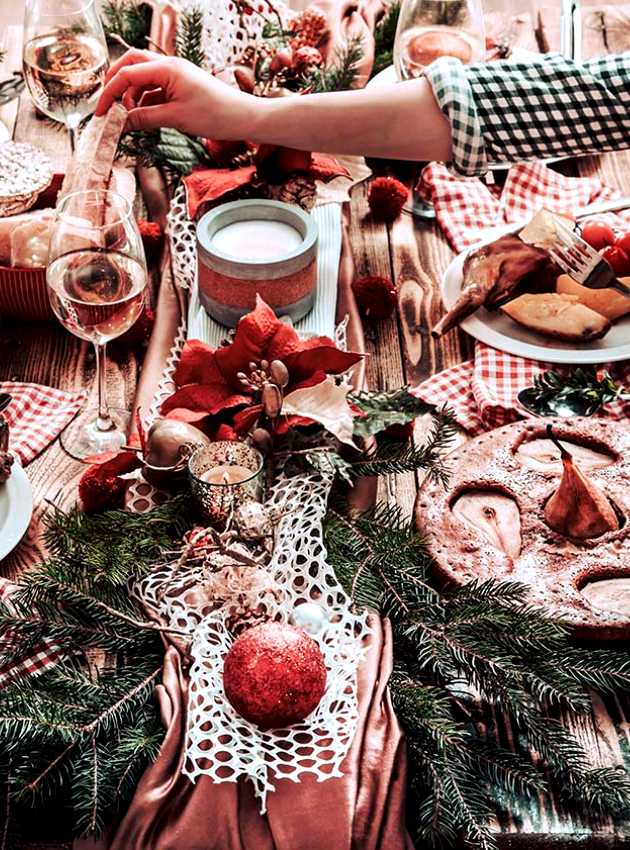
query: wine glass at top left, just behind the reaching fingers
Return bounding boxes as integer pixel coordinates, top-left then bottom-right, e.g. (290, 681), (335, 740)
(22, 0), (108, 151)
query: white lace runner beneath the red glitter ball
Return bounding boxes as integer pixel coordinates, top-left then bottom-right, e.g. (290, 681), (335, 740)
(135, 474), (369, 812)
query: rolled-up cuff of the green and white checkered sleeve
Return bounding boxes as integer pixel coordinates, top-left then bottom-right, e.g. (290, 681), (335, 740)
(425, 56), (488, 176)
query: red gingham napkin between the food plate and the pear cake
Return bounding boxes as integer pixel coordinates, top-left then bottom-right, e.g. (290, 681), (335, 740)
(414, 342), (630, 436)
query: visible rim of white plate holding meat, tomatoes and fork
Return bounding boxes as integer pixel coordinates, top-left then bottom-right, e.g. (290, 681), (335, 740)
(442, 225), (630, 366)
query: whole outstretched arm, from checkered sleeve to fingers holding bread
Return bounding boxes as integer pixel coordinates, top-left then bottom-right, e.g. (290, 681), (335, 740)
(97, 51), (630, 175)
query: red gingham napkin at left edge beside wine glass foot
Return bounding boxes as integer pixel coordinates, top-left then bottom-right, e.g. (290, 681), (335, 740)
(0, 381), (87, 466)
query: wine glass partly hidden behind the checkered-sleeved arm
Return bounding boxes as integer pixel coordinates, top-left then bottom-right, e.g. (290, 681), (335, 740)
(394, 0), (486, 218)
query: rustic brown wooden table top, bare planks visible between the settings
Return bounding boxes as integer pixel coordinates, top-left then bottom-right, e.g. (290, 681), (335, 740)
(0, 0), (630, 847)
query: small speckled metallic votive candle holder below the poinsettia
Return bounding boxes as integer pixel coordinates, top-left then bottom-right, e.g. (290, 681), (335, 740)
(188, 440), (264, 526)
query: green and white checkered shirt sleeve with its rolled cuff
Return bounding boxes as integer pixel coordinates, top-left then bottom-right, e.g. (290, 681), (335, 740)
(426, 52), (630, 174)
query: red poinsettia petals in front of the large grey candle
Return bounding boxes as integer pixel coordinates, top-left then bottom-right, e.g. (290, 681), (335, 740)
(162, 297), (362, 436)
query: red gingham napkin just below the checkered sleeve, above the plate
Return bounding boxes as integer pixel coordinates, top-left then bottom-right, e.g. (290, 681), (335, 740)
(418, 162), (620, 252)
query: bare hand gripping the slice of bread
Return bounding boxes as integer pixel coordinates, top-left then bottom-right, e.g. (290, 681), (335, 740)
(95, 50), (259, 140)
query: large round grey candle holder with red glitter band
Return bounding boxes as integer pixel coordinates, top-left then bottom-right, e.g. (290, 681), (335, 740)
(197, 200), (317, 327)
